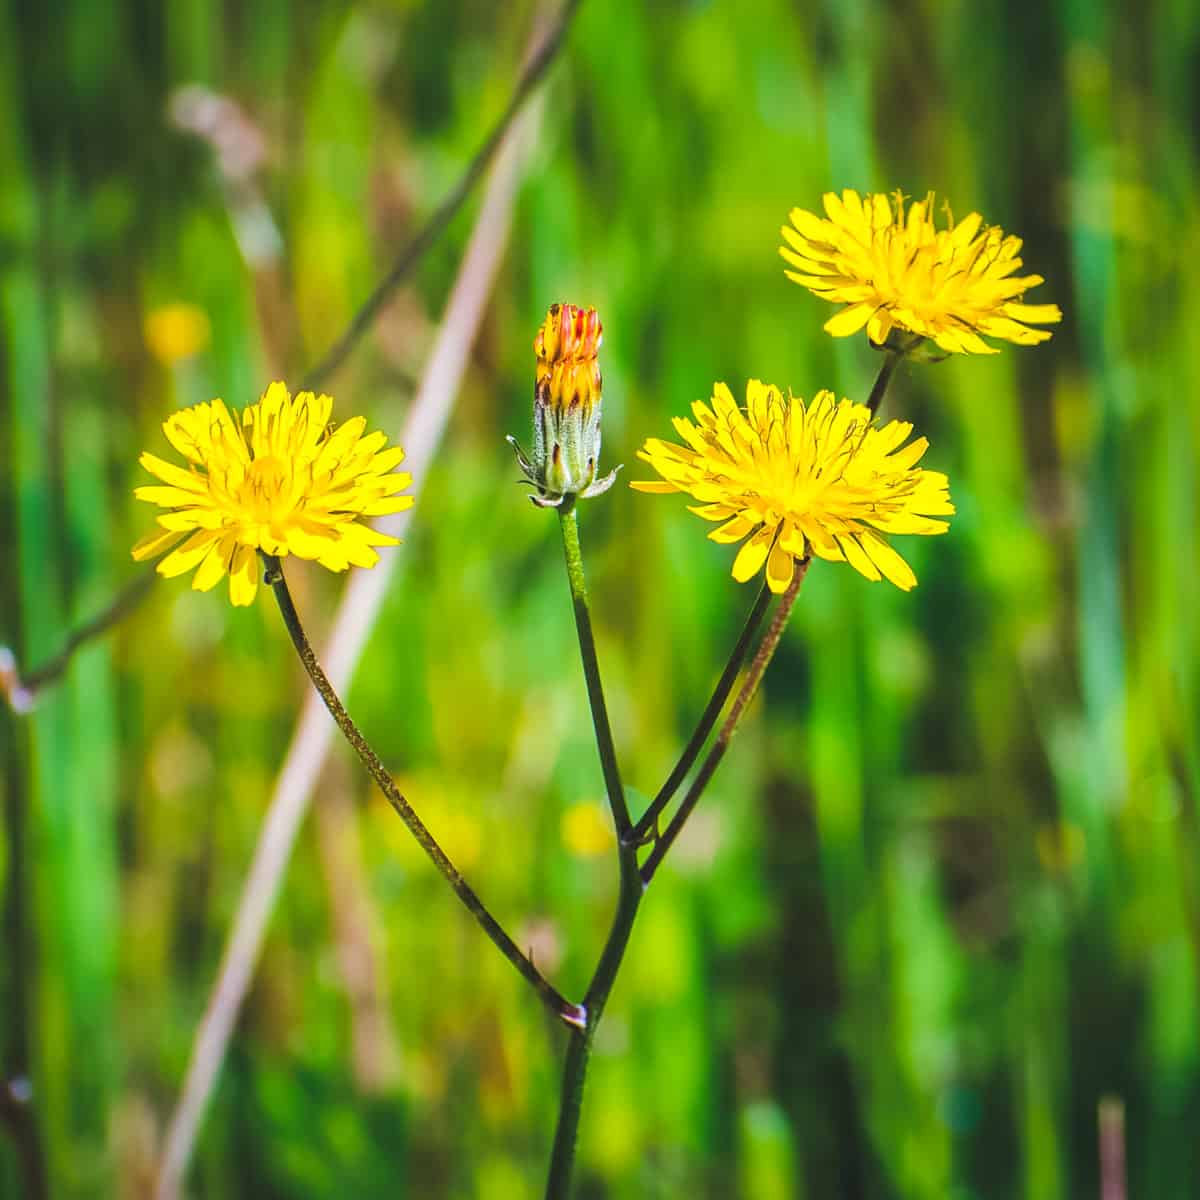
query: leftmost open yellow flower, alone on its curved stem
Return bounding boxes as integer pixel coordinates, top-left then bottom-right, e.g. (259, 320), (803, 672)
(133, 383), (413, 605)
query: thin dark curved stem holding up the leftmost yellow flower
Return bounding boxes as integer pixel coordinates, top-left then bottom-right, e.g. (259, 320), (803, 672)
(263, 554), (584, 1027)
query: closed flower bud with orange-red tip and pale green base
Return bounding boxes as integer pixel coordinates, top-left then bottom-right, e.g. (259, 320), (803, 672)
(509, 304), (620, 508)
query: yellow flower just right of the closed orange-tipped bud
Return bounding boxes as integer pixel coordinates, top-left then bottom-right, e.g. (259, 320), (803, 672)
(630, 379), (954, 593)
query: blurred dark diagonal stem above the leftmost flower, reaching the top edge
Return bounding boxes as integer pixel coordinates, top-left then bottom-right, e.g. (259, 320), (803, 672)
(302, 0), (582, 388)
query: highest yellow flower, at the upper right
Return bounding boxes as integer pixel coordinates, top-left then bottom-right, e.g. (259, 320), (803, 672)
(779, 188), (1062, 354)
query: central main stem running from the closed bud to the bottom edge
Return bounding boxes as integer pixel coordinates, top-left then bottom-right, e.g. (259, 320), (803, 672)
(546, 497), (646, 1200)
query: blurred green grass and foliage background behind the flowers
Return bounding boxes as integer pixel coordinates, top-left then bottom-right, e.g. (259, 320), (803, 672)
(0, 0), (1200, 1200)
